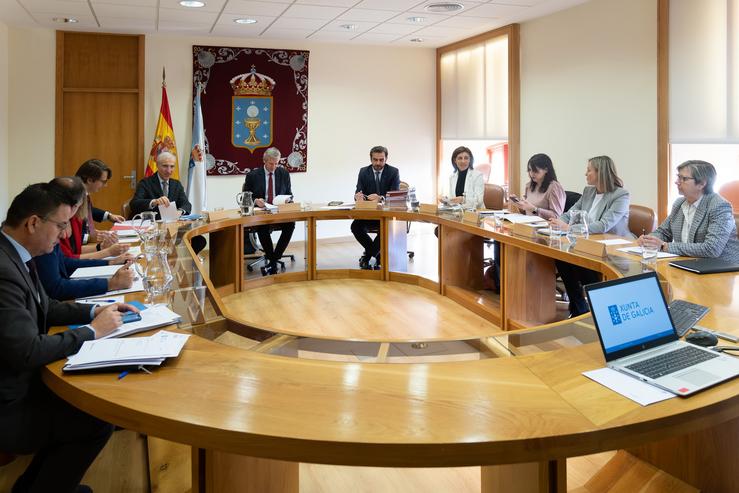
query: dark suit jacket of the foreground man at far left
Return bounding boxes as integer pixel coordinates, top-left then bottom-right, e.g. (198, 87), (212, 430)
(0, 234), (94, 408)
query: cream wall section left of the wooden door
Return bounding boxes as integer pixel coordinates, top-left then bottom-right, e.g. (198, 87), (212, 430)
(8, 28), (56, 198)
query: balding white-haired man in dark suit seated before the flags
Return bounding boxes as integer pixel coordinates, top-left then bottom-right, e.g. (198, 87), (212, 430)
(130, 151), (192, 218)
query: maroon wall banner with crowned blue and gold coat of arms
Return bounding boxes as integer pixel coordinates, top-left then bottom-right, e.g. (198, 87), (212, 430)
(192, 45), (309, 175)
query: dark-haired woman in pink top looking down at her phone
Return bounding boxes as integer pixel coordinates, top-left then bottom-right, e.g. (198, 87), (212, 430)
(510, 154), (566, 219)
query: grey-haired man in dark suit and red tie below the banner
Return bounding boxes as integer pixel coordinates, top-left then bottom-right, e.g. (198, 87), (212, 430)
(243, 147), (295, 275)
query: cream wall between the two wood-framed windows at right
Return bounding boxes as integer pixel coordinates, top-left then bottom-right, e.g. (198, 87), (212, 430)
(521, 0), (657, 210)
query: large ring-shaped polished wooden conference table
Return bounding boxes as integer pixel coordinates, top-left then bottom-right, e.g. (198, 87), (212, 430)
(44, 206), (739, 491)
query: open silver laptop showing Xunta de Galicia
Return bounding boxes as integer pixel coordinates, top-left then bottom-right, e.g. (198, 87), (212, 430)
(585, 272), (739, 396)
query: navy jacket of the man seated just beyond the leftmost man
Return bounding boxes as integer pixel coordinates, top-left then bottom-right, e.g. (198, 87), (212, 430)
(33, 245), (108, 300)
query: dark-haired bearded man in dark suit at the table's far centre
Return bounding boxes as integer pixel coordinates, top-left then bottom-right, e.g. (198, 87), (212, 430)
(351, 146), (400, 270)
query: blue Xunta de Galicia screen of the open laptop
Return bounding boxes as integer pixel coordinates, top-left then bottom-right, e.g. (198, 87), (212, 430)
(585, 272), (677, 361)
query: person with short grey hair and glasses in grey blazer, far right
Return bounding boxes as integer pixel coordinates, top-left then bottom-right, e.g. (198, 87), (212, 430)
(638, 160), (739, 262)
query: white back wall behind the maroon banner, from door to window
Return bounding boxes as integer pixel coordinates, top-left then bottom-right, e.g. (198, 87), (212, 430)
(145, 36), (436, 236)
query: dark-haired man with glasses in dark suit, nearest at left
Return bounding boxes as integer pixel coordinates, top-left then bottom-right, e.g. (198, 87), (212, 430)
(0, 183), (135, 493)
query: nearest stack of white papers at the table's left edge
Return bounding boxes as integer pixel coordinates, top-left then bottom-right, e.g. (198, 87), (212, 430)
(63, 328), (190, 371)
